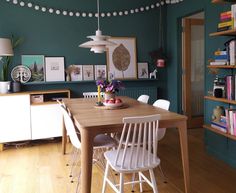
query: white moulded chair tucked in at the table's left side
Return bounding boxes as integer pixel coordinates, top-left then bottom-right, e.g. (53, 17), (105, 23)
(60, 103), (117, 192)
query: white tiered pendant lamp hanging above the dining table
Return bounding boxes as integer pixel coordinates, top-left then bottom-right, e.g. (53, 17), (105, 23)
(79, 0), (116, 53)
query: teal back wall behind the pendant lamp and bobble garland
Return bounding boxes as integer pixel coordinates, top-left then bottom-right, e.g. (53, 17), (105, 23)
(0, 0), (167, 97)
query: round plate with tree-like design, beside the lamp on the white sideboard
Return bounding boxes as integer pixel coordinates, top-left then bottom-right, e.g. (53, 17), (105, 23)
(11, 65), (31, 83)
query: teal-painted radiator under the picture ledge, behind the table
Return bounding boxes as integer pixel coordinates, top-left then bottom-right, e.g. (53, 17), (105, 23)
(118, 87), (157, 104)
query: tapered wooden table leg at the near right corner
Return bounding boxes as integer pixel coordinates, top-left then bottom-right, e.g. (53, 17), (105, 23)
(177, 121), (190, 193)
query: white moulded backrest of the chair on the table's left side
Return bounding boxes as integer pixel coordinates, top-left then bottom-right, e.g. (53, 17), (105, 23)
(60, 105), (81, 149)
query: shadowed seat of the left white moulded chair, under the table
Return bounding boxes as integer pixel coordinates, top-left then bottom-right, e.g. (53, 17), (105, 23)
(93, 134), (117, 149)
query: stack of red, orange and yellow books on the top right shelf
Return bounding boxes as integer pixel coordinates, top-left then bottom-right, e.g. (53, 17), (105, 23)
(217, 11), (234, 32)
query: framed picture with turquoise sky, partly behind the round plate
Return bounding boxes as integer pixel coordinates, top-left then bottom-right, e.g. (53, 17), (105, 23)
(21, 55), (45, 82)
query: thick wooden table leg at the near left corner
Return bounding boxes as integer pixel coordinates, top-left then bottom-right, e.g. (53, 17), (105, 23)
(81, 129), (93, 193)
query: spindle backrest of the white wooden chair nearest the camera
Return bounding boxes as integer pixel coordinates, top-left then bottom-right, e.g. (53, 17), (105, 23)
(115, 115), (160, 170)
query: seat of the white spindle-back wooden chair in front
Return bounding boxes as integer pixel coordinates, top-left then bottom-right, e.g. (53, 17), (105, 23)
(104, 147), (161, 173)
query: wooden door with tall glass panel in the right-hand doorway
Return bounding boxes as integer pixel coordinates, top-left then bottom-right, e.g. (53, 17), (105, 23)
(182, 18), (205, 128)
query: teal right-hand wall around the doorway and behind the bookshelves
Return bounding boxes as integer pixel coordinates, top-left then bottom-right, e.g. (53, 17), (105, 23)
(167, 0), (236, 167)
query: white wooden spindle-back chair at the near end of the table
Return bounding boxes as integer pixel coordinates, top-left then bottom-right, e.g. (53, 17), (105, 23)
(102, 115), (160, 193)
